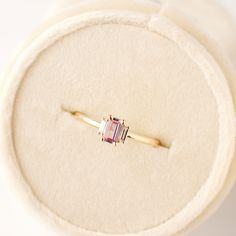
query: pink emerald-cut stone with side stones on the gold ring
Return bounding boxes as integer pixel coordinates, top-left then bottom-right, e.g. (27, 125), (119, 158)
(99, 117), (129, 144)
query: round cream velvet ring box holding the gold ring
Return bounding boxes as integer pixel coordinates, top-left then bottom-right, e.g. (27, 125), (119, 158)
(1, 0), (236, 236)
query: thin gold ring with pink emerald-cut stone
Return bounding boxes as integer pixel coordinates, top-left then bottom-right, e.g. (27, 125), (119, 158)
(71, 111), (164, 147)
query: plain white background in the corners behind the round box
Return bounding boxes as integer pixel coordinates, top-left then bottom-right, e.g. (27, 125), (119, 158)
(0, 0), (236, 236)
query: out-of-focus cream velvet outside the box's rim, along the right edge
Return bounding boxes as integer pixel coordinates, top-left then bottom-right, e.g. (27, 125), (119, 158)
(159, 3), (236, 235)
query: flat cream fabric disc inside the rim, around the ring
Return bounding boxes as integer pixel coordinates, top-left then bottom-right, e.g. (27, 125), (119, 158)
(14, 21), (219, 233)
